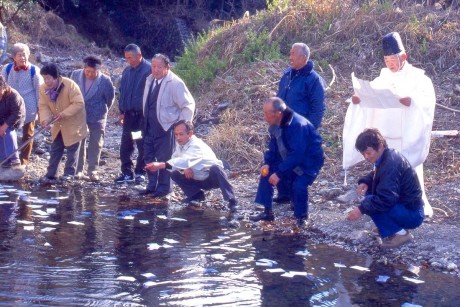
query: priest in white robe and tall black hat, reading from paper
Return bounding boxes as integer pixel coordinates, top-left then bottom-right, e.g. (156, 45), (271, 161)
(344, 32), (436, 216)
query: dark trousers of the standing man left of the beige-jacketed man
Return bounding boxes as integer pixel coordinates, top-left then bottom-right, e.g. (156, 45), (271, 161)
(120, 111), (145, 176)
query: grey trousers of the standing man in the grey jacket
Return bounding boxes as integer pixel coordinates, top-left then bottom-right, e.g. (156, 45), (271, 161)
(77, 123), (105, 173)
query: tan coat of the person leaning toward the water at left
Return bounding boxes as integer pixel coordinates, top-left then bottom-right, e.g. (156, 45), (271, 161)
(38, 77), (88, 146)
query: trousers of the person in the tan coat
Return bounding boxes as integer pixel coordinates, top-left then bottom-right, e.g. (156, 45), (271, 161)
(46, 132), (81, 177)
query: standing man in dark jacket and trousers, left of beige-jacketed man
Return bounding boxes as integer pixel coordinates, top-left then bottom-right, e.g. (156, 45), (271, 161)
(115, 44), (150, 183)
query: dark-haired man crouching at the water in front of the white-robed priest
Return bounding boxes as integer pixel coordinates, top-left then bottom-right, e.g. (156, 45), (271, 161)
(347, 129), (424, 248)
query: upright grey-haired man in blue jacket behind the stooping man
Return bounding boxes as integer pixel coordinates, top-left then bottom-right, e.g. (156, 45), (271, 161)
(274, 43), (326, 203)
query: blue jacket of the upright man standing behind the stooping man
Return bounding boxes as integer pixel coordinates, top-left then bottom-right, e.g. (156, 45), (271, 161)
(277, 60), (326, 129)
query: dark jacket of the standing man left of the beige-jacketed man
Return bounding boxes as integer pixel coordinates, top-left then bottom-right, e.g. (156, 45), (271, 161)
(118, 59), (152, 114)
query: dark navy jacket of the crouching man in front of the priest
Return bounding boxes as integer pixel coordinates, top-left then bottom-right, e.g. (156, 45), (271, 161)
(358, 148), (423, 214)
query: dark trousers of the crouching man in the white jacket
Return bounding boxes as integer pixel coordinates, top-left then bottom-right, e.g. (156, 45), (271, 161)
(171, 165), (235, 201)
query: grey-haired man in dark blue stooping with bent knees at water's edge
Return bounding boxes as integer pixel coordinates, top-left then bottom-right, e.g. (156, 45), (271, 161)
(250, 97), (324, 226)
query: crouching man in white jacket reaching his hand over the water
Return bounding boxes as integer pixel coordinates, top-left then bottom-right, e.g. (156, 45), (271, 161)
(145, 120), (237, 212)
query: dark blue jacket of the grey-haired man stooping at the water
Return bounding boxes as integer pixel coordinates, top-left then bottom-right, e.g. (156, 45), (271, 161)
(264, 108), (324, 182)
